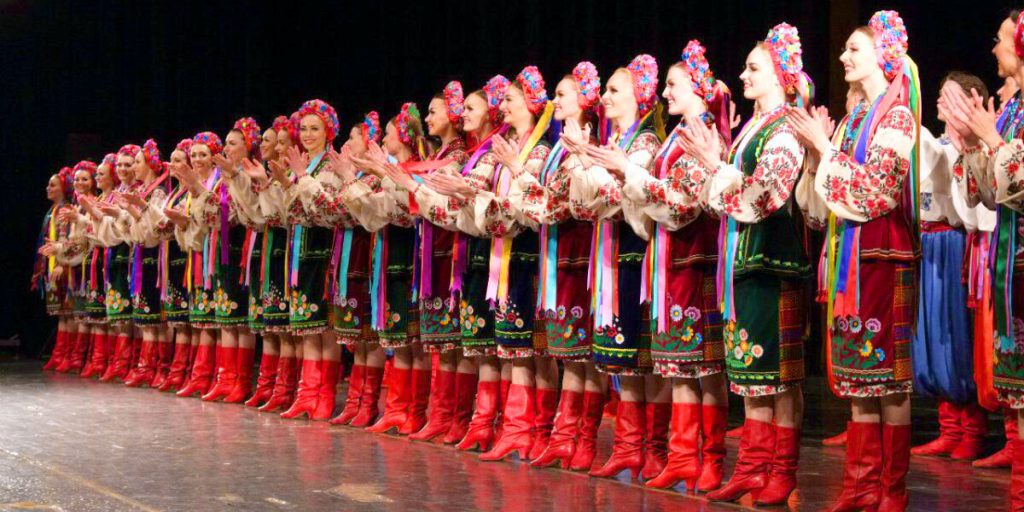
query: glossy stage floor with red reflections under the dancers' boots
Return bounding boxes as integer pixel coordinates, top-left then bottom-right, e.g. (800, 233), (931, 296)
(0, 364), (1010, 512)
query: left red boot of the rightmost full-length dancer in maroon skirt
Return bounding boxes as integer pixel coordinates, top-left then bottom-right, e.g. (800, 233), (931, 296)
(829, 421), (882, 512)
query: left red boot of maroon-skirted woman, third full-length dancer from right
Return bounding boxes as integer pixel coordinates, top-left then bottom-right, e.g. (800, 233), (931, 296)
(644, 402), (700, 494)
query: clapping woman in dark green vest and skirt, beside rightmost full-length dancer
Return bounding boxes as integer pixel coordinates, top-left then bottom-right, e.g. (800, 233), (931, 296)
(680, 24), (810, 504)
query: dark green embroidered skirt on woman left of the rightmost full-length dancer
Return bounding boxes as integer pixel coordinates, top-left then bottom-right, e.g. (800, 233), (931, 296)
(724, 272), (807, 396)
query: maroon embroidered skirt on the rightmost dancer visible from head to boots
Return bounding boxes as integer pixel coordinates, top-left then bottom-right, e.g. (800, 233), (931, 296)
(829, 260), (918, 397)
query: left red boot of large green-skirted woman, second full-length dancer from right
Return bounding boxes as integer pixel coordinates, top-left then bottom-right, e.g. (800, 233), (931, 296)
(708, 418), (775, 502)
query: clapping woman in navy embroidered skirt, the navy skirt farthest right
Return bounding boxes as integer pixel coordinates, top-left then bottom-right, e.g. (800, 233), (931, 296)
(569, 55), (672, 479)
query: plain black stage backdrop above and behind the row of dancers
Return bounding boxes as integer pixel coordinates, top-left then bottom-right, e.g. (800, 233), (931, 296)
(0, 0), (1024, 354)
